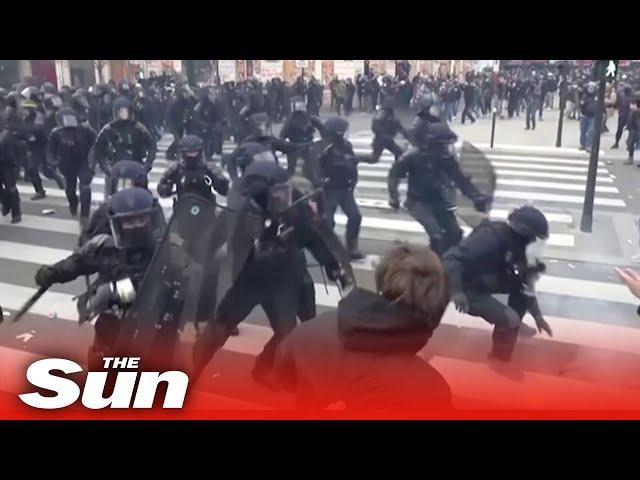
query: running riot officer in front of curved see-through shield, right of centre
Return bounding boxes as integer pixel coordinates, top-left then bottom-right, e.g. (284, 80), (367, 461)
(388, 117), (489, 256)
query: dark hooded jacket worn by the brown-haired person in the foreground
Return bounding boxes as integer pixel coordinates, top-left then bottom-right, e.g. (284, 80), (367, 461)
(274, 289), (452, 416)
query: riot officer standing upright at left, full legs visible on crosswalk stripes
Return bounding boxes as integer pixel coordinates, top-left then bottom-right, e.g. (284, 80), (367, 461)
(47, 107), (96, 226)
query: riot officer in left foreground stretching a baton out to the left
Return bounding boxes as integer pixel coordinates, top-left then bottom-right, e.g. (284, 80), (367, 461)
(35, 188), (164, 370)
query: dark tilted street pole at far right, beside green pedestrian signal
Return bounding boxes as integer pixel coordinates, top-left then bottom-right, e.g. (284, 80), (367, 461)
(580, 60), (606, 232)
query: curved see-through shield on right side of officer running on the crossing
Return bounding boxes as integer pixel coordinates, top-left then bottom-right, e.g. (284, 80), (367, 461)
(456, 142), (496, 227)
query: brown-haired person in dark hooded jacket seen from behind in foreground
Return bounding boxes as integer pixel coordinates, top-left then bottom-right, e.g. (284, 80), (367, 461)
(274, 243), (451, 416)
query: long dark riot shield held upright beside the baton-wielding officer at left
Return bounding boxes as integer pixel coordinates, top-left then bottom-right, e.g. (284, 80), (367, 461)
(117, 194), (226, 364)
